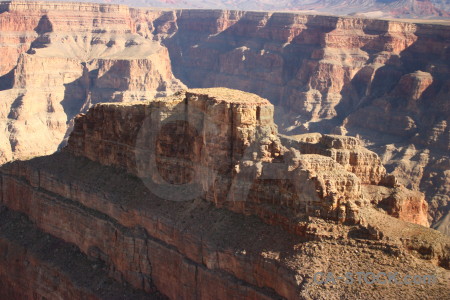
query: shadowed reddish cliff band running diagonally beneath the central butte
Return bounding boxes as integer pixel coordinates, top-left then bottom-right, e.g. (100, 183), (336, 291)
(1, 155), (297, 299)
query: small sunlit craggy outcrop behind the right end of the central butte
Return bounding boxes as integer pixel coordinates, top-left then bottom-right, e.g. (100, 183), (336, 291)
(280, 133), (429, 226)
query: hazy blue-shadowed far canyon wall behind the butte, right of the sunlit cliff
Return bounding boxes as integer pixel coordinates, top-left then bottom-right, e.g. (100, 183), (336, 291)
(133, 10), (450, 229)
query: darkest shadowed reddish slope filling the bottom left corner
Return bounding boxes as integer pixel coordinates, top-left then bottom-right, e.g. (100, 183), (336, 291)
(0, 206), (160, 300)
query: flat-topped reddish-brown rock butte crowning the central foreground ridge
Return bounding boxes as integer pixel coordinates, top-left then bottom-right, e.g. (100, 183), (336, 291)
(65, 88), (426, 230)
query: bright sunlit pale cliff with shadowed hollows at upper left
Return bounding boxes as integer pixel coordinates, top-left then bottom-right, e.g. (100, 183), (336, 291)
(0, 1), (183, 163)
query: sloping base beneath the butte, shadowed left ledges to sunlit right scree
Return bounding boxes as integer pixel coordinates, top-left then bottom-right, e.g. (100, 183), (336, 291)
(0, 119), (450, 299)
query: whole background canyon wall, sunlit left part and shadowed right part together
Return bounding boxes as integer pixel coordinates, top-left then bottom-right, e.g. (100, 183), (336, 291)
(0, 2), (450, 227)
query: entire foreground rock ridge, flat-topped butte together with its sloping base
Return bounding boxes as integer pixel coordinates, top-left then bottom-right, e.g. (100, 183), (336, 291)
(0, 89), (450, 299)
